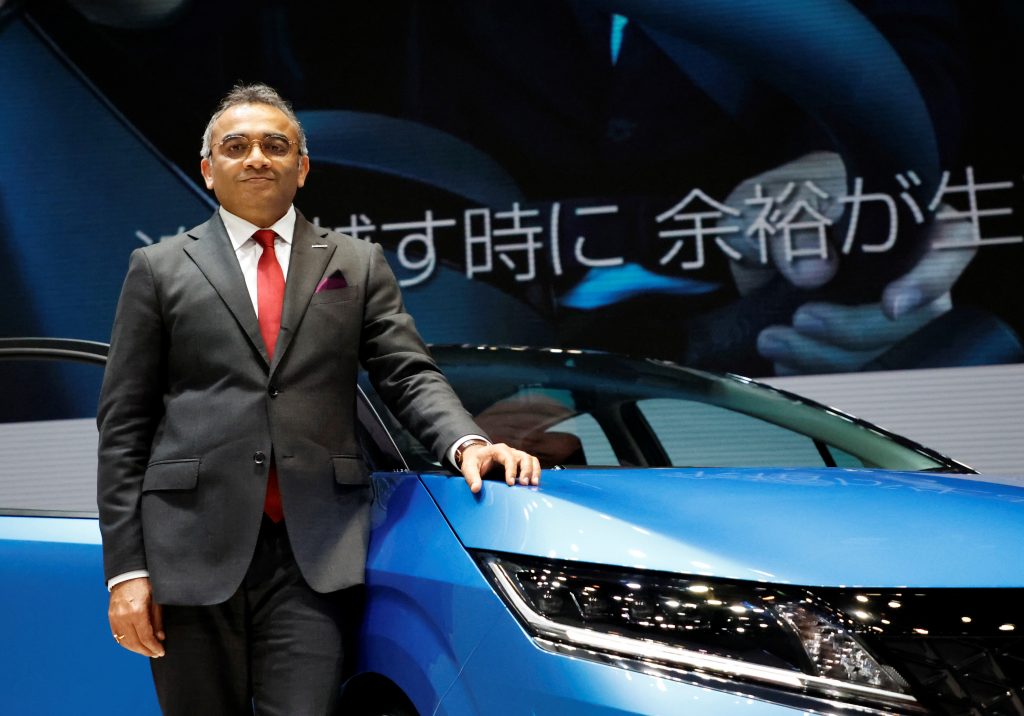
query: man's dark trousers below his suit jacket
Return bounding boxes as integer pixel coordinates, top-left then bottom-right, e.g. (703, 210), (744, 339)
(150, 516), (364, 716)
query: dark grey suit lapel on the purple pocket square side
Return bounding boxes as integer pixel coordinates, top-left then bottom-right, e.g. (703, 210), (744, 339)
(270, 214), (337, 374)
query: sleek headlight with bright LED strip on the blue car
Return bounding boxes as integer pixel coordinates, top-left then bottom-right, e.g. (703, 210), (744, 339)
(475, 553), (925, 713)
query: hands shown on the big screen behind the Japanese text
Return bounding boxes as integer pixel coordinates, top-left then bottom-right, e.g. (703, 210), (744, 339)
(726, 152), (977, 375)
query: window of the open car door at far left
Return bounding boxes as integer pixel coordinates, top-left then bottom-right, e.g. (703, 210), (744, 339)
(0, 360), (103, 514)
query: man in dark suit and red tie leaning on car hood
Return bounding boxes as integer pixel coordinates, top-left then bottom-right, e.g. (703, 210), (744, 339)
(97, 85), (540, 715)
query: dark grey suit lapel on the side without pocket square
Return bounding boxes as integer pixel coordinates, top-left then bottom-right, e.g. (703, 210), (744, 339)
(185, 214), (270, 365)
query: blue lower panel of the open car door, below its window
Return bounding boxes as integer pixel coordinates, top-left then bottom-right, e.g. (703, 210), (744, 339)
(0, 516), (160, 715)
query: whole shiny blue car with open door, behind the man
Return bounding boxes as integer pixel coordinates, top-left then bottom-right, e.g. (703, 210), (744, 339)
(0, 339), (1024, 716)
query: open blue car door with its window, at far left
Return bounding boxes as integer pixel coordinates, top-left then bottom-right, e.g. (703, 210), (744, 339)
(0, 339), (160, 714)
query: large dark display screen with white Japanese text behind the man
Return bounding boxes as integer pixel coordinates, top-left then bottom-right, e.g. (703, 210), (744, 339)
(0, 0), (1024, 467)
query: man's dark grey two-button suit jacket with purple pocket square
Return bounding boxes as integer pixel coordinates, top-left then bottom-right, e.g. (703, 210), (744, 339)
(97, 213), (483, 604)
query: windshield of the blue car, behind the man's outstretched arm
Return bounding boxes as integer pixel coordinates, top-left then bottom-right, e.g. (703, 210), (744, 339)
(362, 346), (971, 472)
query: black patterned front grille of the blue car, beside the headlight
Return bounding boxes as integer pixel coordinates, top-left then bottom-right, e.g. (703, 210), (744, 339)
(865, 635), (1024, 716)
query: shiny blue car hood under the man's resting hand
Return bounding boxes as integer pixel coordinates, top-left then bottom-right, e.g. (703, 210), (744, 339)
(421, 468), (1024, 587)
